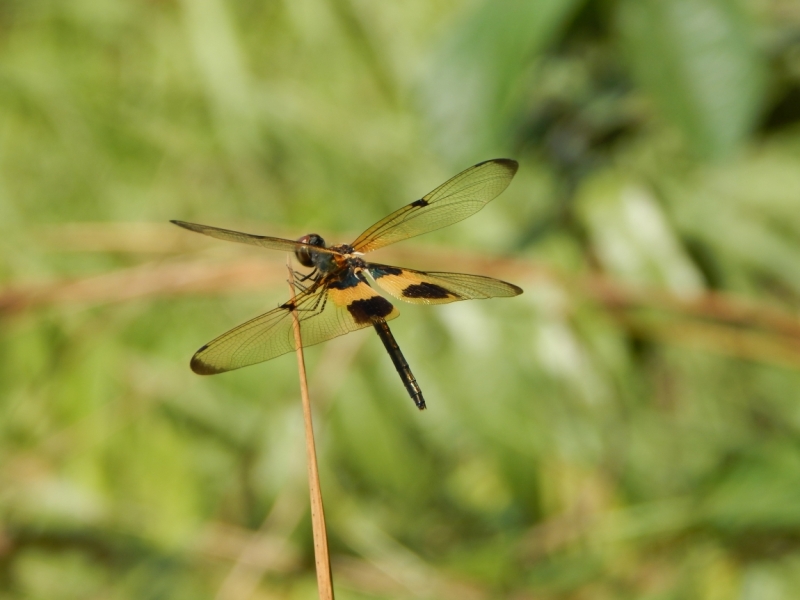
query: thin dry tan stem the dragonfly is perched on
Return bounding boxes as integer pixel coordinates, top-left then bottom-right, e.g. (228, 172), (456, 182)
(287, 264), (333, 600)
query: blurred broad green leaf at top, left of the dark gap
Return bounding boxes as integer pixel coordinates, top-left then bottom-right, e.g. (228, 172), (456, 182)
(422, 0), (583, 157)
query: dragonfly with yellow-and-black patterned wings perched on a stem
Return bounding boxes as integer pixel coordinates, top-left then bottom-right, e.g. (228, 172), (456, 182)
(170, 158), (522, 410)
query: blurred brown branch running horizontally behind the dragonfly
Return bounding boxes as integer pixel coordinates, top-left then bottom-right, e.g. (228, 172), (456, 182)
(0, 224), (800, 367)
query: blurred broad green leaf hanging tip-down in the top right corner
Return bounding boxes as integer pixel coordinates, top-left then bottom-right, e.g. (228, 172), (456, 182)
(619, 0), (765, 159)
